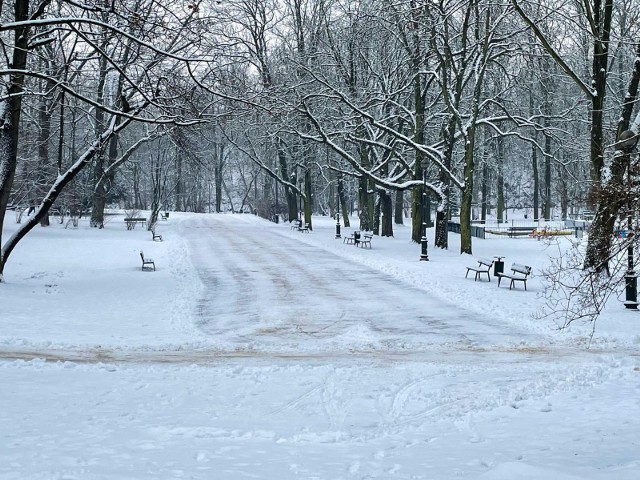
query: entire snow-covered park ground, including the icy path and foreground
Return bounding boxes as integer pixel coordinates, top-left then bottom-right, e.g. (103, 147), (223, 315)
(0, 212), (640, 480)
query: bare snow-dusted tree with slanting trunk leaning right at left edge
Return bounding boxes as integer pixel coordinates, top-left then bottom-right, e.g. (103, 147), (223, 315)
(0, 0), (215, 281)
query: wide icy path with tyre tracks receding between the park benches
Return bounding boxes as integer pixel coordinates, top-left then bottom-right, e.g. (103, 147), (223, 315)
(183, 216), (529, 353)
